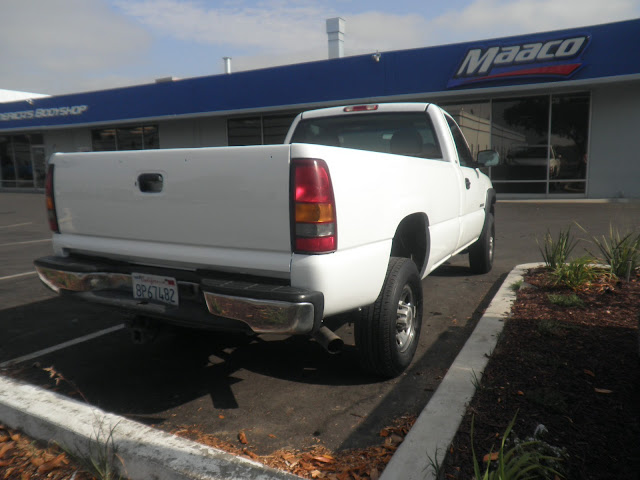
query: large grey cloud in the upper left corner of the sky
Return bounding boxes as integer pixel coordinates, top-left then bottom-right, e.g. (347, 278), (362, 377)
(0, 0), (150, 93)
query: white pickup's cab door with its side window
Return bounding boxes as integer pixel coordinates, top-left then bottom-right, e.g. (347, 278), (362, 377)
(445, 115), (486, 248)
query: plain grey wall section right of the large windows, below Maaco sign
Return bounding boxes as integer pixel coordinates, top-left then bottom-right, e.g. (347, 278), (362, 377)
(588, 83), (640, 198)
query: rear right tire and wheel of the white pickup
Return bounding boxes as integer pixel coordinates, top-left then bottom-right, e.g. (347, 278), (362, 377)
(354, 257), (422, 378)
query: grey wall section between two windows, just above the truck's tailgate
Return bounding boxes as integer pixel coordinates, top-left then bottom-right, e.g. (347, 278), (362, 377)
(158, 117), (227, 148)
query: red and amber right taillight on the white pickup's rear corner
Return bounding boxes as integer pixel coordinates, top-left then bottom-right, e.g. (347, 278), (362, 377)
(291, 158), (338, 253)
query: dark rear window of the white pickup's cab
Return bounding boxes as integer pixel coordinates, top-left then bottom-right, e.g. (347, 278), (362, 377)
(291, 112), (442, 160)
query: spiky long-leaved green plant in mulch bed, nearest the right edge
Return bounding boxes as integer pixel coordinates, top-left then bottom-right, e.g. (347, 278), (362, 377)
(592, 225), (640, 277)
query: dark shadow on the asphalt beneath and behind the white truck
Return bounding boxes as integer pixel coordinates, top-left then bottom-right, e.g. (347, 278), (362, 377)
(0, 298), (376, 415)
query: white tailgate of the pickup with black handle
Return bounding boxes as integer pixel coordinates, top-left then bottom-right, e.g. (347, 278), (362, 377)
(52, 145), (291, 273)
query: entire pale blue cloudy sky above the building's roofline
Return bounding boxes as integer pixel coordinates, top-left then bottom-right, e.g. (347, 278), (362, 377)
(0, 0), (640, 95)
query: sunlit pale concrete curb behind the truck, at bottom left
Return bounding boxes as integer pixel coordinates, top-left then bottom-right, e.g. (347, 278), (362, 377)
(0, 376), (299, 480)
